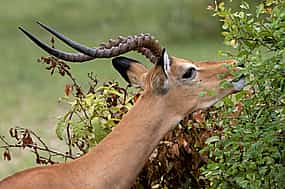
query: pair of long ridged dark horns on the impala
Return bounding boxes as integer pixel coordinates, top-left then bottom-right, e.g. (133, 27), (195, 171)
(20, 22), (162, 63)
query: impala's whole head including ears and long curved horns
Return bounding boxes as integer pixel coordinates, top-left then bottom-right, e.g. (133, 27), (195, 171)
(19, 22), (245, 116)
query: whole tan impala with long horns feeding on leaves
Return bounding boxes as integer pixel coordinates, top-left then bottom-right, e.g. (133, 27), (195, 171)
(0, 22), (244, 189)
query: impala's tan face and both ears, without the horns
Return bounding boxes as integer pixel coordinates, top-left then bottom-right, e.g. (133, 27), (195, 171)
(113, 50), (245, 115)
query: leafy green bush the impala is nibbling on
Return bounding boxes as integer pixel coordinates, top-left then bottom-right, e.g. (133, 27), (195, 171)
(200, 0), (285, 189)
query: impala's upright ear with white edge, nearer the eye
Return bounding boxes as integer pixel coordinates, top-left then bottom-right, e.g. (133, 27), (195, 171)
(152, 48), (171, 95)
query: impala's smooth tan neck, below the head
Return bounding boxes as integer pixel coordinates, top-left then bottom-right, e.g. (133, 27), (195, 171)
(71, 96), (180, 189)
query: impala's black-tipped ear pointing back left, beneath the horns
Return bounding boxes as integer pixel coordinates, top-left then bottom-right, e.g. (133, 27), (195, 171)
(112, 57), (148, 88)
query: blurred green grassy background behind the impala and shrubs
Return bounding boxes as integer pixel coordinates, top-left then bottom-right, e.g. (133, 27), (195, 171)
(0, 0), (231, 179)
